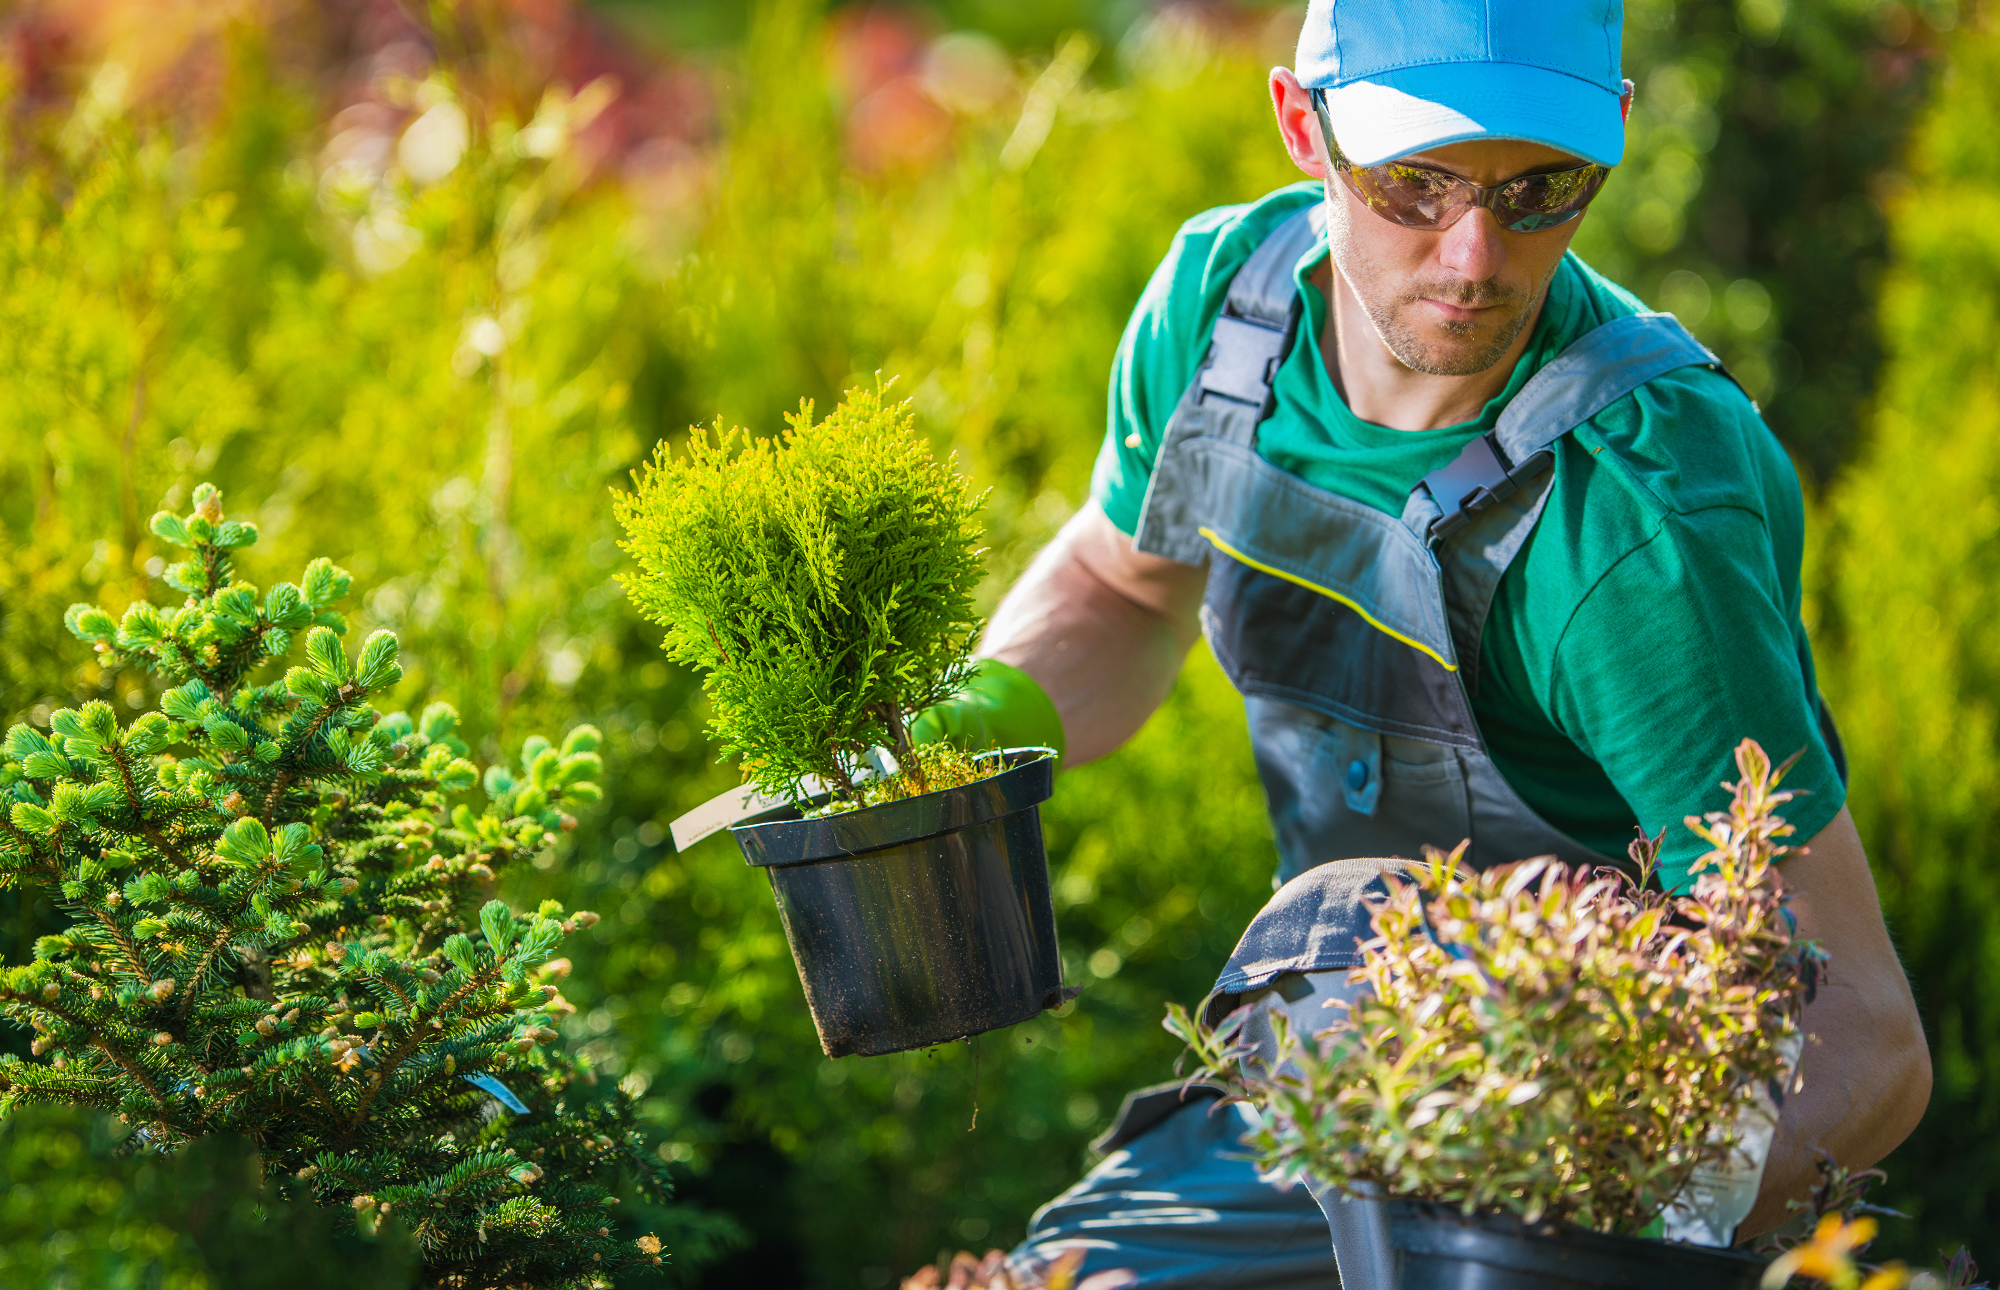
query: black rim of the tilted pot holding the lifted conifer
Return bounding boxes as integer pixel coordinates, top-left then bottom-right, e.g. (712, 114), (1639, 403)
(730, 748), (1056, 868)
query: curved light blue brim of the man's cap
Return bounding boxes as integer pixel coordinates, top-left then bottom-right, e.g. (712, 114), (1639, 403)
(1326, 62), (1624, 166)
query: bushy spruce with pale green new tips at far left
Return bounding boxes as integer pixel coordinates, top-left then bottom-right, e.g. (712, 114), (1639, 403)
(0, 484), (688, 1290)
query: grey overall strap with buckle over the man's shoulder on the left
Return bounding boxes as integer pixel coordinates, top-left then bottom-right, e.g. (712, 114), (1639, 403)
(1190, 202), (1326, 438)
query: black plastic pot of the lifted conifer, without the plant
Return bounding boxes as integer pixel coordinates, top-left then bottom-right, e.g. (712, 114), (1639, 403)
(730, 748), (1062, 1058)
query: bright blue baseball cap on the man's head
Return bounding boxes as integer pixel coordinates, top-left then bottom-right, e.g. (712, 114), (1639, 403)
(1296, 0), (1624, 166)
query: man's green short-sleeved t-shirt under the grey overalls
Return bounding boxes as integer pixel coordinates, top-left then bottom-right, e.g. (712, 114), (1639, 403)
(1092, 184), (1846, 886)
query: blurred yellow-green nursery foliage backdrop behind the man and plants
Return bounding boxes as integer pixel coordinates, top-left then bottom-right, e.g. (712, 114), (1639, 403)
(0, 0), (2000, 1290)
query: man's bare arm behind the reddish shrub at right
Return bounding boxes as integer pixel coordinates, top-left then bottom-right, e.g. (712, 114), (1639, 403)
(1740, 808), (1930, 1236)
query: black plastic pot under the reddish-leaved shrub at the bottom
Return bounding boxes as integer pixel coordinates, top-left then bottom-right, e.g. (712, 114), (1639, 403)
(1388, 1200), (1766, 1290)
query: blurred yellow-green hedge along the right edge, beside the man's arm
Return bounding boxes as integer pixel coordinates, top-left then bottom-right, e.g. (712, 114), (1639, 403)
(1814, 12), (2000, 1262)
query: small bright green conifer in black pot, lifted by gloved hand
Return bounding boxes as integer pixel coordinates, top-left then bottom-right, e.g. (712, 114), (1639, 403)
(616, 388), (1062, 1056)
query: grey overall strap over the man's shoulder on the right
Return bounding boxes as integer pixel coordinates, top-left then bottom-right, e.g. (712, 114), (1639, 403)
(1404, 314), (1734, 544)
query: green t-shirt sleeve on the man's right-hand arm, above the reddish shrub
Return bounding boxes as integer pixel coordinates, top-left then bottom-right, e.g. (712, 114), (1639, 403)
(1550, 506), (1846, 888)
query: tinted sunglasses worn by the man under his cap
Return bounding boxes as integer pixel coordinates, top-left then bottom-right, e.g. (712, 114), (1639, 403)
(1312, 90), (1612, 232)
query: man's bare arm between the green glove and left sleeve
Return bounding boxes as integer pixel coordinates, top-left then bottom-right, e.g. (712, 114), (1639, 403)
(978, 502), (1204, 766)
